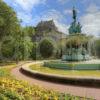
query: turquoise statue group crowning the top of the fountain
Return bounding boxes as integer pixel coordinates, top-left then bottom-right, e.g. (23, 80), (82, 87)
(69, 7), (82, 35)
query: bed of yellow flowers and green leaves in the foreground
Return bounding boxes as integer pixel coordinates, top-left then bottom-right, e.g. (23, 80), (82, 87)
(0, 78), (87, 100)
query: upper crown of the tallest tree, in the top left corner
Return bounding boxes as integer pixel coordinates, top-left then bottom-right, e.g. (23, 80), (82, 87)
(0, 0), (20, 41)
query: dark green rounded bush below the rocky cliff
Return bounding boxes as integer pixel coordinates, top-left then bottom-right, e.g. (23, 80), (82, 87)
(40, 39), (54, 58)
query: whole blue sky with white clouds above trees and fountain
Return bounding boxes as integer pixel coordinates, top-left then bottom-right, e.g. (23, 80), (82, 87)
(3, 0), (100, 36)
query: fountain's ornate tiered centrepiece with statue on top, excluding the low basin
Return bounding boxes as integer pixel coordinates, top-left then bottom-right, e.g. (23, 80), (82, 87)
(62, 7), (90, 61)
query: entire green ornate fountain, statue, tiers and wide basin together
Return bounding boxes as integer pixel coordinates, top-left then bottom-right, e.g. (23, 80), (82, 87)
(44, 7), (100, 70)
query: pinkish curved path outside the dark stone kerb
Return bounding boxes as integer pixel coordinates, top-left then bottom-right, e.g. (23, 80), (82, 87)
(11, 62), (100, 100)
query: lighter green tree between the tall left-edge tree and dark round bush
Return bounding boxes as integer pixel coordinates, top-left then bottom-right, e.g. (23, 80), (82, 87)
(14, 30), (33, 62)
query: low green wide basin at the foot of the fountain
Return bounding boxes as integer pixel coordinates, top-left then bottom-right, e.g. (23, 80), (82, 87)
(44, 60), (100, 70)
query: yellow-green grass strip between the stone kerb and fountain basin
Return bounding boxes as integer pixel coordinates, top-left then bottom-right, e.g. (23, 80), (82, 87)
(30, 64), (100, 77)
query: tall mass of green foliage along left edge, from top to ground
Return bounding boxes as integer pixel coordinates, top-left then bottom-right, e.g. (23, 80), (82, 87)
(0, 0), (20, 60)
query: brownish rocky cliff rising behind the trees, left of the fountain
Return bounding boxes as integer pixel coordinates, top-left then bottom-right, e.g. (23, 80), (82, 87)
(33, 20), (66, 41)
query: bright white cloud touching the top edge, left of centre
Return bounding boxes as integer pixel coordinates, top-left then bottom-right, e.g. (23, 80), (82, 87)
(12, 0), (46, 11)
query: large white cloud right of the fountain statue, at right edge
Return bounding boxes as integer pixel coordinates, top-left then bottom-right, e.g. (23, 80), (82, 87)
(80, 4), (100, 36)
